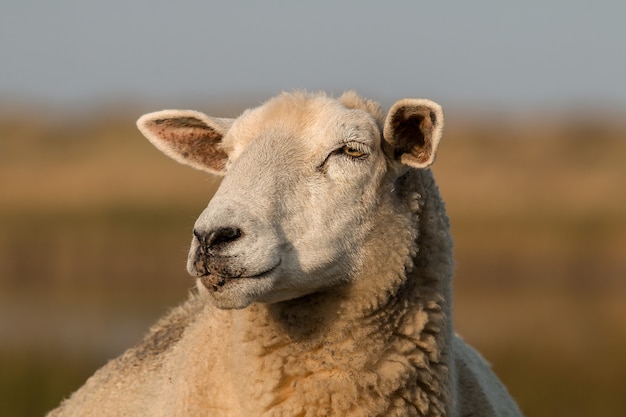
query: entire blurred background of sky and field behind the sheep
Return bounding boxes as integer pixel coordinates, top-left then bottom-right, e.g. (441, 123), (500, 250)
(0, 0), (626, 417)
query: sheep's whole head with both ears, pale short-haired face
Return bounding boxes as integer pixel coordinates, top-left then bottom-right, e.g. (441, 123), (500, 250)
(138, 93), (443, 308)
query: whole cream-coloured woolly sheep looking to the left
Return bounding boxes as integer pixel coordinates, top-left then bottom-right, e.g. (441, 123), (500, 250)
(49, 92), (521, 417)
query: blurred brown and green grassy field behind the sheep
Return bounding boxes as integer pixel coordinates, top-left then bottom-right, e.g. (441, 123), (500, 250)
(0, 102), (626, 417)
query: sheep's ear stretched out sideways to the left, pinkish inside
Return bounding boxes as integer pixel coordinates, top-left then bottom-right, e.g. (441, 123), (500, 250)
(137, 110), (233, 175)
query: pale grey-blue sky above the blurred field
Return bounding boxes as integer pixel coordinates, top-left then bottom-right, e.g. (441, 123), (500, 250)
(0, 0), (626, 108)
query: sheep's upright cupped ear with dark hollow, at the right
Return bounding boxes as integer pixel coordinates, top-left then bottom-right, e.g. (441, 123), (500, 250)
(383, 99), (443, 168)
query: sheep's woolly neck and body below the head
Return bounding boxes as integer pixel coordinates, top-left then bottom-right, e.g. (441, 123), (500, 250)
(49, 93), (521, 417)
